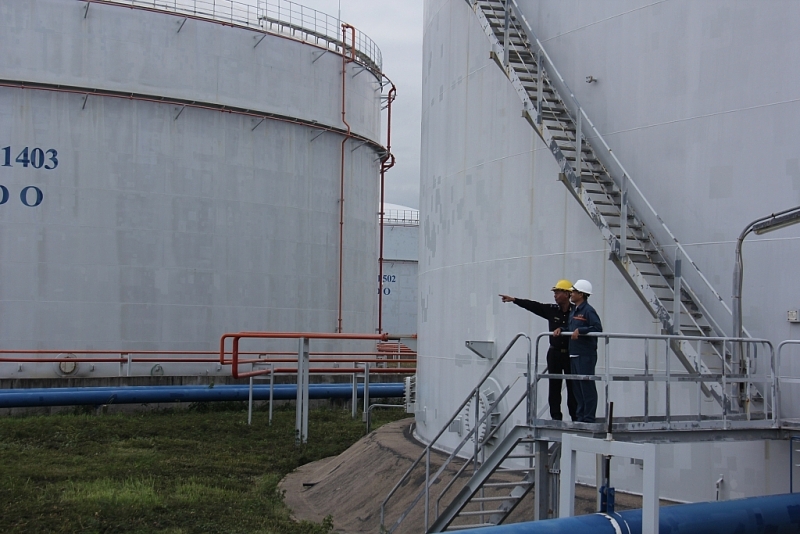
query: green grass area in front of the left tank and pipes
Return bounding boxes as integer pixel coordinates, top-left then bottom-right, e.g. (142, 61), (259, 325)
(0, 403), (406, 534)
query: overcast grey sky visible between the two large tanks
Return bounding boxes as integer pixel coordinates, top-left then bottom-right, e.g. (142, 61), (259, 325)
(250, 0), (422, 209)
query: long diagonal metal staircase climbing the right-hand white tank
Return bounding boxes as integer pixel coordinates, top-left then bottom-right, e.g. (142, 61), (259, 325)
(466, 0), (750, 412)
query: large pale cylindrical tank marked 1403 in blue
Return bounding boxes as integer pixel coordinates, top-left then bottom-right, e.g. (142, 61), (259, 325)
(0, 0), (383, 373)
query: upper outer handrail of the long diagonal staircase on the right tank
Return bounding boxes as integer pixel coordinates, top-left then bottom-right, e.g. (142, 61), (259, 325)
(500, 0), (736, 337)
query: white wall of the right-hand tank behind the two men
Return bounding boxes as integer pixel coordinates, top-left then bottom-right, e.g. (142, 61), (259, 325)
(417, 0), (800, 500)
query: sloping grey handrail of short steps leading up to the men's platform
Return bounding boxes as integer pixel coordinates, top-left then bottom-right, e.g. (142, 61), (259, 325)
(381, 332), (531, 532)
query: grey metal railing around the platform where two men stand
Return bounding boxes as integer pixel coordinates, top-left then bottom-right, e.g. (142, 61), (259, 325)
(528, 332), (780, 431)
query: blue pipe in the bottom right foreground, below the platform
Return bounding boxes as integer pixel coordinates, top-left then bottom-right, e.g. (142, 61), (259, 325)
(446, 493), (800, 534)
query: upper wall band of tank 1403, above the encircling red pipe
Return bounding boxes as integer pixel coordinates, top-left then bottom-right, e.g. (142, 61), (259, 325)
(0, 0), (380, 139)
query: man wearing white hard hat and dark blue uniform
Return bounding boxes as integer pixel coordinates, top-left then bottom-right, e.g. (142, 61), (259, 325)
(553, 280), (603, 423)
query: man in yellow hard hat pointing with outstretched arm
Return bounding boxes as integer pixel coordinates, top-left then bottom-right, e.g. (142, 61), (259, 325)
(500, 280), (577, 421)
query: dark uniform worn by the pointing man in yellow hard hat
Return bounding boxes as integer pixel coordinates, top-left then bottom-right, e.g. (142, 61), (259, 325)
(514, 298), (578, 421)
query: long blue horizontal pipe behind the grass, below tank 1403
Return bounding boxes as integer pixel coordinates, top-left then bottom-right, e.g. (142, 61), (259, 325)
(0, 382), (405, 408)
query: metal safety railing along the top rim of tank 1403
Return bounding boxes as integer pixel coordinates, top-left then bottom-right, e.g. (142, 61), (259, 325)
(89, 0), (383, 76)
